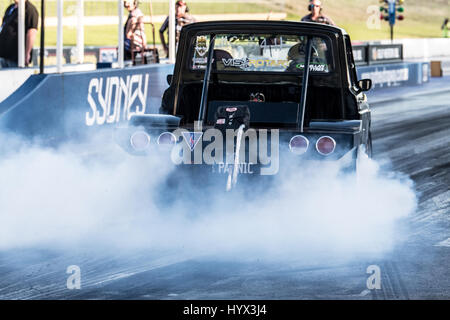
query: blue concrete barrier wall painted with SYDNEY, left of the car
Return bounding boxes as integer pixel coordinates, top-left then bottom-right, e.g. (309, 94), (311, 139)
(0, 65), (173, 140)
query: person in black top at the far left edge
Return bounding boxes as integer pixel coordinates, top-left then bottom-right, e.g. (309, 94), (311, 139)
(0, 0), (39, 68)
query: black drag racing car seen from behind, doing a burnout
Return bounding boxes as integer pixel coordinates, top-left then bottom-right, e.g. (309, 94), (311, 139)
(119, 21), (372, 189)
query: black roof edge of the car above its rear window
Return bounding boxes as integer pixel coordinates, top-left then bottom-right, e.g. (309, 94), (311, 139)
(183, 20), (347, 35)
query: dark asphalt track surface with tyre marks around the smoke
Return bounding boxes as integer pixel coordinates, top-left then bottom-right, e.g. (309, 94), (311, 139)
(0, 91), (450, 299)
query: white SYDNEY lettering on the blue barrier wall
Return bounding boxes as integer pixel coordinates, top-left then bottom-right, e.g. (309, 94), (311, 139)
(85, 74), (149, 126)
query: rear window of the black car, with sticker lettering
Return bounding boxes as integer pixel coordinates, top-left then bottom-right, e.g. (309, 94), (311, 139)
(190, 34), (333, 73)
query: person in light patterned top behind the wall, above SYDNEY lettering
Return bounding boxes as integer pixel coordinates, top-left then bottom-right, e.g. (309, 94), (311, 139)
(123, 0), (147, 60)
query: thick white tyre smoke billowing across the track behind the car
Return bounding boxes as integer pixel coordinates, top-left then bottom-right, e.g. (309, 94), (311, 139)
(0, 134), (416, 260)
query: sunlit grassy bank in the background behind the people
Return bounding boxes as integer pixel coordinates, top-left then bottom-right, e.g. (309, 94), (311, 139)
(0, 0), (450, 46)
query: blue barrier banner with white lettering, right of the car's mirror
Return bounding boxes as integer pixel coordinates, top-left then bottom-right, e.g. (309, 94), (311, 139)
(357, 62), (430, 89)
